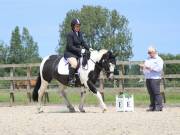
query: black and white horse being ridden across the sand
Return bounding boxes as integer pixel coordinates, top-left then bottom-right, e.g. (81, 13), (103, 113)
(33, 49), (116, 112)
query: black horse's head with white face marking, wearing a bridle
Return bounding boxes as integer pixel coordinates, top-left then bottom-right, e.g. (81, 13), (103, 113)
(99, 51), (116, 79)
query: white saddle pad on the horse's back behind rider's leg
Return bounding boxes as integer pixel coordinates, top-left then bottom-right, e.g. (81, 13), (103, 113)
(58, 57), (69, 75)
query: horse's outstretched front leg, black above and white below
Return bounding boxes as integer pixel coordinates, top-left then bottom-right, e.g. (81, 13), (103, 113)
(87, 80), (107, 112)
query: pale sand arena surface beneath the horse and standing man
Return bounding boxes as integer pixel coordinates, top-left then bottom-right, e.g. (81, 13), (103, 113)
(0, 105), (180, 135)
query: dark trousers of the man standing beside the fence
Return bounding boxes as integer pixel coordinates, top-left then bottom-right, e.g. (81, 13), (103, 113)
(146, 79), (163, 110)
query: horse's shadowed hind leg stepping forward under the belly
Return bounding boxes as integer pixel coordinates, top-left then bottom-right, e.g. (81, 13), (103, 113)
(59, 84), (75, 112)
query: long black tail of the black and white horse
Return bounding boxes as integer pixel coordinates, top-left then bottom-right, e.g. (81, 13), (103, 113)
(33, 73), (41, 102)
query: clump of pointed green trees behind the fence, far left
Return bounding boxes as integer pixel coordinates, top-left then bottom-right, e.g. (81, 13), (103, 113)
(0, 26), (41, 76)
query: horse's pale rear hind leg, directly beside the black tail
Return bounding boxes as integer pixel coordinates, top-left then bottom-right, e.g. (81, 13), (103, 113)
(38, 80), (48, 113)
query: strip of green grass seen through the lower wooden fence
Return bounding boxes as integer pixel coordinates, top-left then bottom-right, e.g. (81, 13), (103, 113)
(0, 89), (180, 105)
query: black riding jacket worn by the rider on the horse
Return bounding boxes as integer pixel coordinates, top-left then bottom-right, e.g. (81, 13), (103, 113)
(64, 31), (89, 58)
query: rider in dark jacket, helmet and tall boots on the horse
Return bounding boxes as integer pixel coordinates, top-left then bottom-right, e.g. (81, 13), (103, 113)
(64, 19), (90, 86)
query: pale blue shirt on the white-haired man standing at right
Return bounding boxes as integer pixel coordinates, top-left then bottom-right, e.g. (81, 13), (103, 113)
(143, 55), (164, 79)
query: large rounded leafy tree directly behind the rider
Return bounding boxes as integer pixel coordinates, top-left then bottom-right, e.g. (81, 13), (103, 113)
(57, 6), (133, 60)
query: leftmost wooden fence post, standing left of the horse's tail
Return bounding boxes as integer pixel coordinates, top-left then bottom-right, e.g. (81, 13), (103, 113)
(9, 67), (15, 106)
